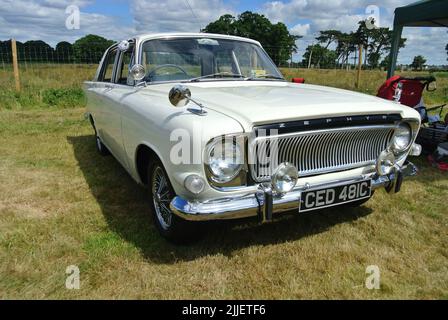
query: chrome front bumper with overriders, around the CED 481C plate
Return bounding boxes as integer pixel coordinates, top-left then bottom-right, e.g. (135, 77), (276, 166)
(170, 162), (417, 221)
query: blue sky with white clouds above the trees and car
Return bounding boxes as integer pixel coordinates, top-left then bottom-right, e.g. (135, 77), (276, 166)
(0, 0), (448, 64)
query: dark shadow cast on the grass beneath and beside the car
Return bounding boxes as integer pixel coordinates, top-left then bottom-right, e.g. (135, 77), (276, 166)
(67, 135), (372, 264)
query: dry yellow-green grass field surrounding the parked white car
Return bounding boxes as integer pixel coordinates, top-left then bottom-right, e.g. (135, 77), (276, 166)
(0, 63), (448, 299)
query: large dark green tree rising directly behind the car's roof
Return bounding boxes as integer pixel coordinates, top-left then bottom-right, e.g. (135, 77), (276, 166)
(202, 11), (301, 65)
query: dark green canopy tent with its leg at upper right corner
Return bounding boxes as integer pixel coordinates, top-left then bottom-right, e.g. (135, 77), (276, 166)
(387, 0), (448, 78)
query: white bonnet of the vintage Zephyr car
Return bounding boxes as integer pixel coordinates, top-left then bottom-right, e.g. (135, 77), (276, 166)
(145, 81), (419, 131)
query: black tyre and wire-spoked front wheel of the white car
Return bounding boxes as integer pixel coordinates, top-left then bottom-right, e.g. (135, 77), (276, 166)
(148, 160), (201, 244)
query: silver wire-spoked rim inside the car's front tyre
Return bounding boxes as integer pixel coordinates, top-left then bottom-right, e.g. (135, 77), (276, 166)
(152, 167), (172, 230)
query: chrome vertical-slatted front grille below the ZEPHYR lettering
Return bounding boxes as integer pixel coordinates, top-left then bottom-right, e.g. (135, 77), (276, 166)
(249, 125), (395, 182)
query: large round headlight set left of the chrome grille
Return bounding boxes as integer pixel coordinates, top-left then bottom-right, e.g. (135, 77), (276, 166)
(208, 140), (244, 183)
